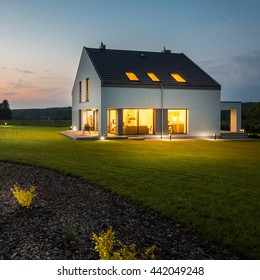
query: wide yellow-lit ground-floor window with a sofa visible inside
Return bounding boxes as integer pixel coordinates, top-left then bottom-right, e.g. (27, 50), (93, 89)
(123, 109), (153, 135)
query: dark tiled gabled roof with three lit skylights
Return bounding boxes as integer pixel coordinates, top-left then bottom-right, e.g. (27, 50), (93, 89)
(84, 47), (221, 89)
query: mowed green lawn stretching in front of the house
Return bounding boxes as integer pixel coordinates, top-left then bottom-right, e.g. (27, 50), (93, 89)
(0, 126), (260, 259)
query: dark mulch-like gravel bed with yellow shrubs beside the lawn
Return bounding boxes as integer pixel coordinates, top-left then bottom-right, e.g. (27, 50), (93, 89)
(0, 162), (236, 260)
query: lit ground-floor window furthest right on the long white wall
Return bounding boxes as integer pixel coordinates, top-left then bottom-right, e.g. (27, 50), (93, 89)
(168, 110), (187, 134)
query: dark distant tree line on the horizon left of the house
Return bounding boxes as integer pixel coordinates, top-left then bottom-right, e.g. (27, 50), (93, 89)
(12, 107), (72, 120)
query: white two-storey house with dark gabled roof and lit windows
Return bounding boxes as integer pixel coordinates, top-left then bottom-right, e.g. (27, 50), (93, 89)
(72, 43), (241, 138)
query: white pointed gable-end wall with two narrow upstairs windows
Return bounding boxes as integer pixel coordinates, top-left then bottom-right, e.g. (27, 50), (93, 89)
(72, 49), (101, 130)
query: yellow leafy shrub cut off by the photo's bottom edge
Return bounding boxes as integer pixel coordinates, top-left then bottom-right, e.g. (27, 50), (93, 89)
(92, 226), (155, 260)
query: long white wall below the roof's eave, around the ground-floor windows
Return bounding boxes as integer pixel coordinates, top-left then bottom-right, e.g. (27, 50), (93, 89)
(101, 85), (220, 137)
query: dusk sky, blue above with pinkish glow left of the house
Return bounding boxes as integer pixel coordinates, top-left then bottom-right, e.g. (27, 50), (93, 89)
(0, 0), (260, 109)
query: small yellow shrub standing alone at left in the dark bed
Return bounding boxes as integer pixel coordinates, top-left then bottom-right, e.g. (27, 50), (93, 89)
(11, 183), (36, 208)
